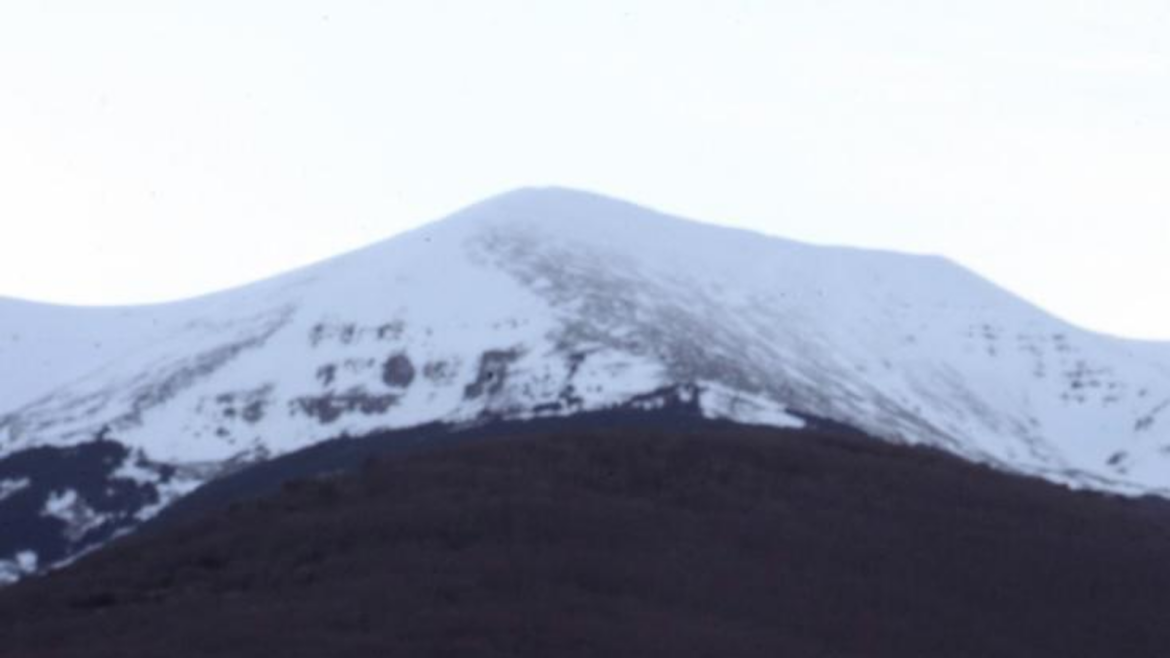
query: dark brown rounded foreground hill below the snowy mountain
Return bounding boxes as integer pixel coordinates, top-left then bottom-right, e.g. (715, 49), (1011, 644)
(0, 420), (1170, 658)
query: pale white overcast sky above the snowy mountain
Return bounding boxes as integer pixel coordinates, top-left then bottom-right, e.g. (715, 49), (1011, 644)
(0, 0), (1170, 338)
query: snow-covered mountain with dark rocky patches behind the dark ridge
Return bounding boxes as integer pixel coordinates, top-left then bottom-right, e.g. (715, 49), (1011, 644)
(0, 190), (1170, 578)
